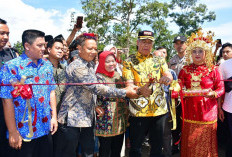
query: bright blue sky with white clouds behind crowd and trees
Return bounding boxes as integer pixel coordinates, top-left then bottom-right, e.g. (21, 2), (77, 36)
(0, 0), (232, 44)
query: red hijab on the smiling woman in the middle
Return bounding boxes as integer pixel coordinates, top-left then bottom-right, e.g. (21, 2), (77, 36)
(96, 51), (116, 78)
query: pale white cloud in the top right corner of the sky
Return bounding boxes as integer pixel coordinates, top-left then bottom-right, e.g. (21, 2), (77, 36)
(200, 0), (232, 10)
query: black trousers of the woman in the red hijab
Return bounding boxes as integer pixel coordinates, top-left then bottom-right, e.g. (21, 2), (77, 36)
(98, 134), (124, 157)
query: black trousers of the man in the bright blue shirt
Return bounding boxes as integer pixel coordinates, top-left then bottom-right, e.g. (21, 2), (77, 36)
(8, 134), (53, 157)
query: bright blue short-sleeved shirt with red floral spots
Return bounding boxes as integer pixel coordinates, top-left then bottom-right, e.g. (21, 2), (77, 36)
(0, 53), (56, 140)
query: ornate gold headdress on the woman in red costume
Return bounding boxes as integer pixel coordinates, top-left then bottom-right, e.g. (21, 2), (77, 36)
(186, 28), (216, 69)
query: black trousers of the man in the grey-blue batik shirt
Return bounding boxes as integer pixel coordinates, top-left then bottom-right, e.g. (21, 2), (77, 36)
(53, 124), (94, 157)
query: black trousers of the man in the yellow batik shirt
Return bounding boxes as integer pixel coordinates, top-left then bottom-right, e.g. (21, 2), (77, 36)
(130, 114), (171, 157)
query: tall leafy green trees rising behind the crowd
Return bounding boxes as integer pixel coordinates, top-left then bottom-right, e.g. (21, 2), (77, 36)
(82, 0), (216, 58)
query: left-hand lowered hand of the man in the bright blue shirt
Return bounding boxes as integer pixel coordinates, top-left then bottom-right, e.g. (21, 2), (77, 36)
(9, 130), (22, 149)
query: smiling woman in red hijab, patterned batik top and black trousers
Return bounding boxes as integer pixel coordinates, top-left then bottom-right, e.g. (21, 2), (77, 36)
(96, 51), (128, 157)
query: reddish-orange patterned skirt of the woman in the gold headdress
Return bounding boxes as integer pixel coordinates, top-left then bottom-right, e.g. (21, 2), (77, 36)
(180, 122), (218, 157)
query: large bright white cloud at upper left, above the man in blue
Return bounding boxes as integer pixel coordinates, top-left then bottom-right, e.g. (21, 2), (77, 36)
(0, 0), (87, 44)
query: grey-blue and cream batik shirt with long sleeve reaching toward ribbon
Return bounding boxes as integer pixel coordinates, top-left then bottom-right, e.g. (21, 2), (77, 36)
(58, 55), (126, 127)
